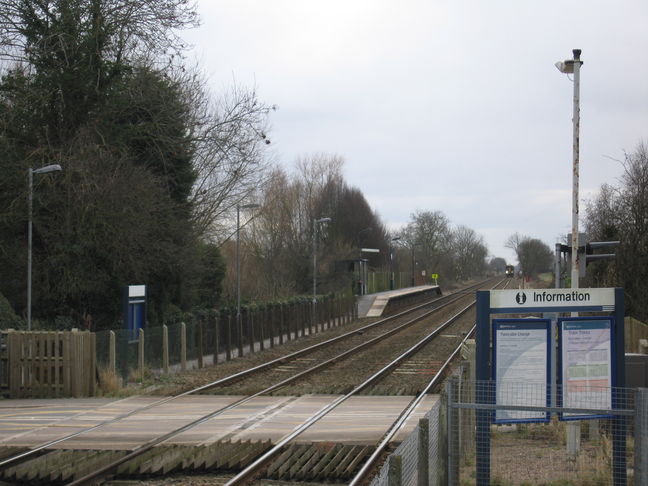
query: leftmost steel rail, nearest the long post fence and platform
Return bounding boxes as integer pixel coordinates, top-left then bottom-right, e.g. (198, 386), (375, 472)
(0, 282), (483, 471)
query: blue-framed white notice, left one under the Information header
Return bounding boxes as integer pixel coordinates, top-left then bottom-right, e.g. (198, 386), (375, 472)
(492, 319), (551, 423)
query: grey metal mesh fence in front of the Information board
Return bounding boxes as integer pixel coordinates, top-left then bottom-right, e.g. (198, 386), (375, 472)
(446, 378), (648, 486)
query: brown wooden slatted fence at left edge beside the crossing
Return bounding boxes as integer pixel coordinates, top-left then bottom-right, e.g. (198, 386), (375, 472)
(0, 331), (97, 398)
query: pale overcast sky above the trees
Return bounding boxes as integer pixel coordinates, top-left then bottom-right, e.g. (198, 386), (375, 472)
(182, 0), (648, 263)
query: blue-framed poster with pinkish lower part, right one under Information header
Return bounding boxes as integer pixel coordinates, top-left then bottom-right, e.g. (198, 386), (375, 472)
(558, 317), (615, 420)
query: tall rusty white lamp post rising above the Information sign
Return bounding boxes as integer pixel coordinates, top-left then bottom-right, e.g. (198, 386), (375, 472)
(556, 49), (583, 289)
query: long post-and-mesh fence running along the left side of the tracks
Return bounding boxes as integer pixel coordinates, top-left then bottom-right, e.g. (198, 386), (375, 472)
(96, 297), (357, 380)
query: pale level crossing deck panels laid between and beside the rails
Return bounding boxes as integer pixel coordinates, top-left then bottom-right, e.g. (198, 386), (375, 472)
(0, 395), (438, 450)
